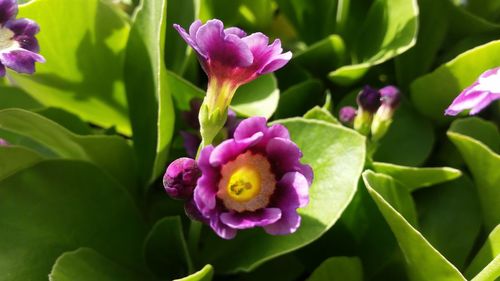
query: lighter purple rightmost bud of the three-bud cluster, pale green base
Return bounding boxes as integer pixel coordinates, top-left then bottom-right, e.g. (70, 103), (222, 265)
(371, 86), (401, 141)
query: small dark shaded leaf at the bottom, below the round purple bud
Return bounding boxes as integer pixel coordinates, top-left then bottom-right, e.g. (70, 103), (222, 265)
(144, 217), (193, 280)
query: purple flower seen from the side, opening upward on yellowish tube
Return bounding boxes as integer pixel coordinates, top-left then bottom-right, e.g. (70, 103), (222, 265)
(174, 19), (292, 113)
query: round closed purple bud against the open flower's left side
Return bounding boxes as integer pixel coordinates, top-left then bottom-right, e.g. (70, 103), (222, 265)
(163, 157), (201, 200)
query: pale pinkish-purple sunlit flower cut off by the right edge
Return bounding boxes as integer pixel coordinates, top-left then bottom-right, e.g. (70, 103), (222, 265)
(445, 67), (500, 116)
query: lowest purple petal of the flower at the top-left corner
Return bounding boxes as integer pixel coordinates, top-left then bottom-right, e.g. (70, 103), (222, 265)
(0, 49), (45, 74)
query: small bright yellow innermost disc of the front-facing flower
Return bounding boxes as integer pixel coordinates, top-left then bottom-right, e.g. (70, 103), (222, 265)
(227, 166), (260, 202)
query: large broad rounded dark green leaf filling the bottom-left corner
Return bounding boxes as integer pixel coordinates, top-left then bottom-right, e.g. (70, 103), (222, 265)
(0, 160), (145, 281)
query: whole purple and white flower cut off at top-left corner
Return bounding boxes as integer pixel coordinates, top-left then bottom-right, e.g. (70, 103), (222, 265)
(0, 0), (45, 77)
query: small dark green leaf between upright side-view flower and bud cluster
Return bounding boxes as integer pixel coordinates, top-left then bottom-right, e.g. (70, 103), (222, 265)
(275, 79), (323, 118)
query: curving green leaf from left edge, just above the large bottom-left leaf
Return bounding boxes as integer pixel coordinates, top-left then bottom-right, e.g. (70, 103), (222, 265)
(0, 109), (137, 195)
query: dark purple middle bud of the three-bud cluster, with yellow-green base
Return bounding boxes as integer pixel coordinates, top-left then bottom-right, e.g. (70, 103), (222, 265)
(354, 85), (380, 136)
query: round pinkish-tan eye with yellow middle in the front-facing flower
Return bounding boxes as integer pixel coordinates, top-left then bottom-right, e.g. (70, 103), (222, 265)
(217, 151), (276, 212)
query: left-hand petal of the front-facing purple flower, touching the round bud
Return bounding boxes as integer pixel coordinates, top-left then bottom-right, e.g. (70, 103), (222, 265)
(194, 145), (220, 214)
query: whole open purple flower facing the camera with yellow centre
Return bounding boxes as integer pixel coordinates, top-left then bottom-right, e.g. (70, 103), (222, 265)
(194, 117), (313, 239)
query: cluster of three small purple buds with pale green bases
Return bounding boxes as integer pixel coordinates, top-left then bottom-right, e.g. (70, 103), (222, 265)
(339, 83), (400, 141)
